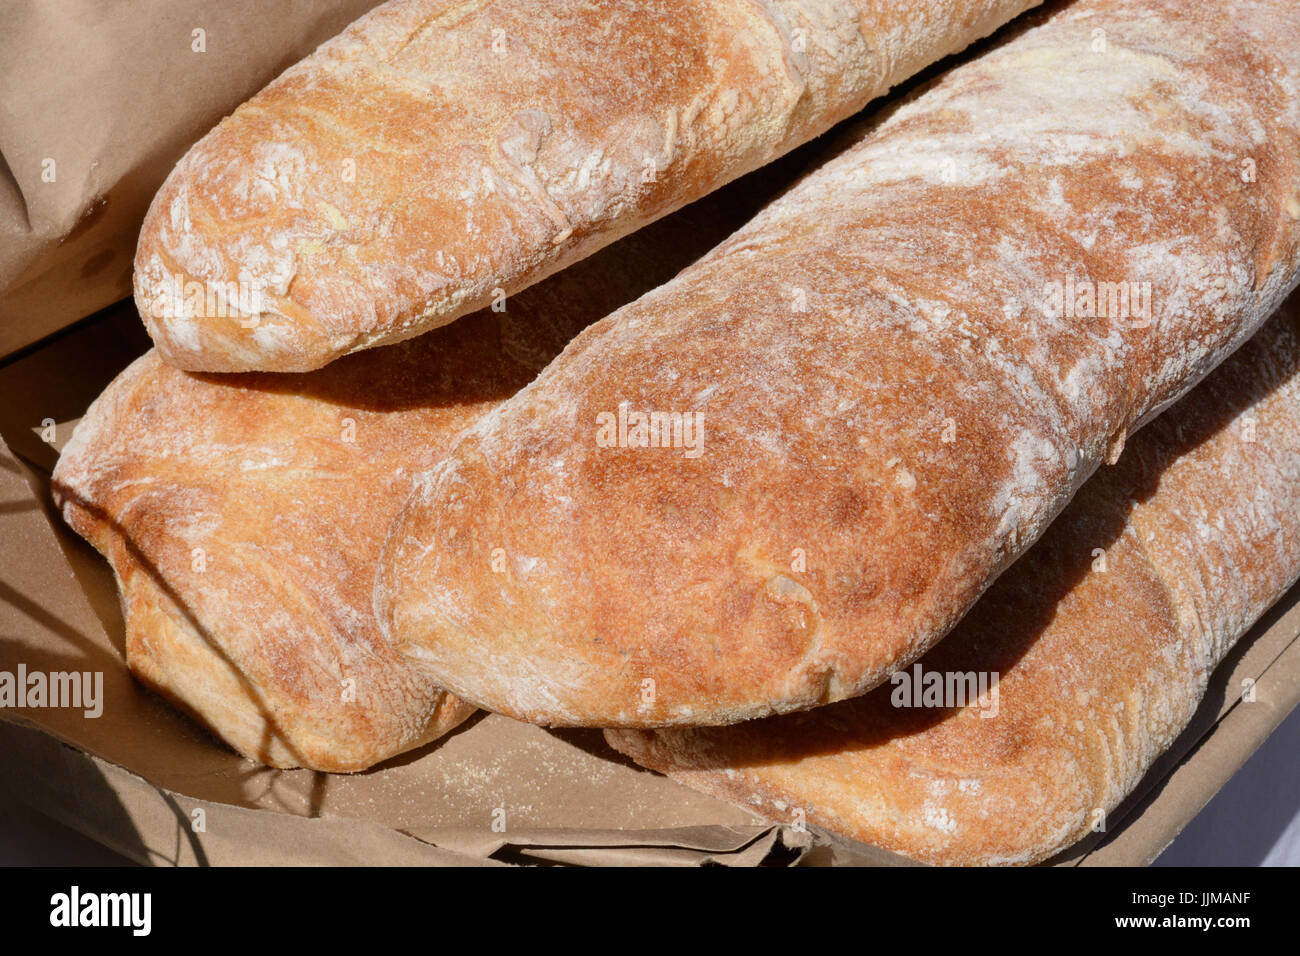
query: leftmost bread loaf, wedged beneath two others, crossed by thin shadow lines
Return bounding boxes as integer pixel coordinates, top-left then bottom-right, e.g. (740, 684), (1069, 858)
(55, 152), (790, 771)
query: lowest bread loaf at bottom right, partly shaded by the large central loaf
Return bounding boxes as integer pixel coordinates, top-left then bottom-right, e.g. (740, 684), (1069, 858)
(607, 297), (1300, 865)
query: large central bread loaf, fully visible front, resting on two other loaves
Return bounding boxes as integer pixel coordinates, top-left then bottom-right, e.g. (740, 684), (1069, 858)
(376, 0), (1300, 727)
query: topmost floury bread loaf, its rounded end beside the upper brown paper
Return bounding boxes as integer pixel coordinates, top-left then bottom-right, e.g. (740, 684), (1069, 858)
(135, 0), (1039, 372)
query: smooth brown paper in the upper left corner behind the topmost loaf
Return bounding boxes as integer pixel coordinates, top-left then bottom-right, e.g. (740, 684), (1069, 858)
(0, 0), (378, 356)
